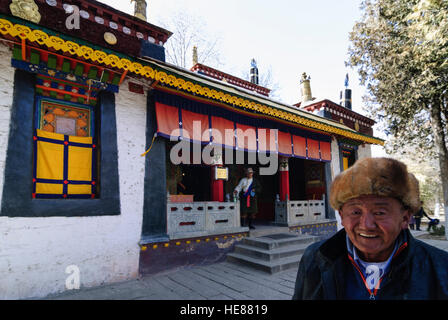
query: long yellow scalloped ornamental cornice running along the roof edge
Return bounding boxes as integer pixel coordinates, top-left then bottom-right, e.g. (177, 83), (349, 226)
(0, 19), (384, 145)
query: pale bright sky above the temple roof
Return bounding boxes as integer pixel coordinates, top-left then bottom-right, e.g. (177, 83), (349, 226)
(100, 0), (385, 156)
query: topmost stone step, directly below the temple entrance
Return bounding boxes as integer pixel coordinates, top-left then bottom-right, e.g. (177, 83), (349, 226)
(243, 233), (316, 250)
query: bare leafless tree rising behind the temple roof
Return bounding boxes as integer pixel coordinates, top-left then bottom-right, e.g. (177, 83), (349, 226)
(160, 12), (222, 69)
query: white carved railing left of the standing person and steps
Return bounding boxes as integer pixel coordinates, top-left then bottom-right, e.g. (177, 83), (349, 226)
(167, 202), (244, 239)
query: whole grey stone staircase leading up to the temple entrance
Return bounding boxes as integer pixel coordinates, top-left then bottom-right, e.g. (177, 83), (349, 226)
(227, 233), (320, 274)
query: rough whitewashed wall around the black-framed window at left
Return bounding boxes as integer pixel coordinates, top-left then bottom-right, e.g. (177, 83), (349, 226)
(0, 41), (146, 299)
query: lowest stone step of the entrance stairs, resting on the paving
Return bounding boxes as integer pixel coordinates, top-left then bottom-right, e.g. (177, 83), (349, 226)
(227, 252), (302, 274)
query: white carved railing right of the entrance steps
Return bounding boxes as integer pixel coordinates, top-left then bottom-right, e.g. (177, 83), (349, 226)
(275, 200), (326, 226)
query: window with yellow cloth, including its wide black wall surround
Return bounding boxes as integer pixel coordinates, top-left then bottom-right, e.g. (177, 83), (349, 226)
(0, 70), (120, 217)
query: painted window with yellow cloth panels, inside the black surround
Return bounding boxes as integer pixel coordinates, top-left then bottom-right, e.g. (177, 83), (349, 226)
(32, 89), (98, 199)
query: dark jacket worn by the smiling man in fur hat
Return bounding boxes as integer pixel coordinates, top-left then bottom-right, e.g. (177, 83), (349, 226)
(293, 229), (448, 300)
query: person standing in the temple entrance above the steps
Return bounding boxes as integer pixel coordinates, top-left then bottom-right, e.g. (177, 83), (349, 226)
(233, 168), (259, 229)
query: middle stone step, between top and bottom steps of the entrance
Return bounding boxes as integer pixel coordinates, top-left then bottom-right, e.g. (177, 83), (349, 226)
(234, 243), (310, 261)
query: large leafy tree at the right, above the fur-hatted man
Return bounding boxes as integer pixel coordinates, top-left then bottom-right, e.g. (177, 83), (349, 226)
(347, 0), (448, 217)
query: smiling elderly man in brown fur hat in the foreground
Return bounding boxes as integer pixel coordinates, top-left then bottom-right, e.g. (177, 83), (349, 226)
(293, 158), (448, 300)
